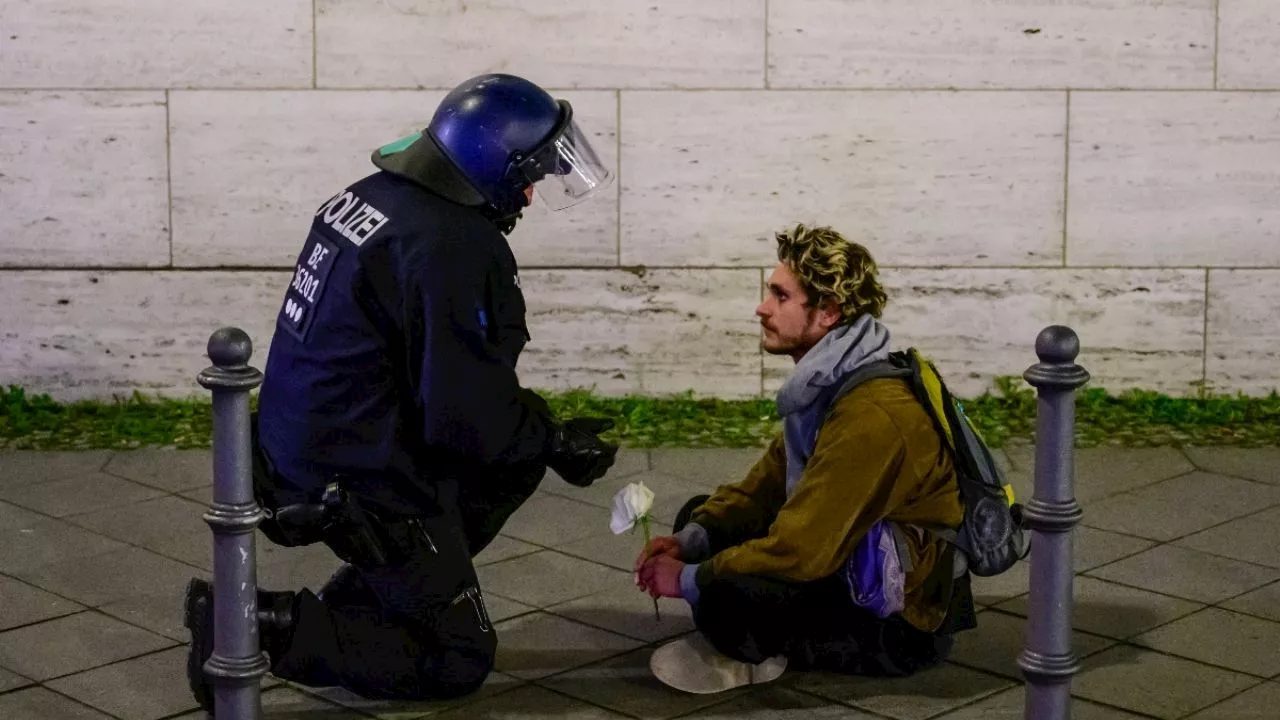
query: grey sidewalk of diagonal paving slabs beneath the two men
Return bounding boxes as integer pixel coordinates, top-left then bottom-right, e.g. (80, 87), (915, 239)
(0, 446), (1280, 720)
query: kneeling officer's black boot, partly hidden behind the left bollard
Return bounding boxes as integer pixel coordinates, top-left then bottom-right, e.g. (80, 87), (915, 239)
(183, 578), (297, 712)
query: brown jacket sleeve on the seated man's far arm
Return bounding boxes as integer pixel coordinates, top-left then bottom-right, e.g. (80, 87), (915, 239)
(677, 434), (787, 552)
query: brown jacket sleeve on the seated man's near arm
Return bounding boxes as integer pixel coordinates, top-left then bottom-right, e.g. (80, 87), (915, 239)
(695, 401), (913, 587)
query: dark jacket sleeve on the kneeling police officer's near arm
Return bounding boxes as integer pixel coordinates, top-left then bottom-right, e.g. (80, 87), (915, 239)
(406, 240), (552, 465)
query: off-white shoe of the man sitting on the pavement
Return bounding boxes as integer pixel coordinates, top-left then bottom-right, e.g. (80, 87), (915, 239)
(649, 632), (787, 694)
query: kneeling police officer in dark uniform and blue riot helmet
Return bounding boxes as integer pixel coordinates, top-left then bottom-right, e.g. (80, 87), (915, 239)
(184, 74), (617, 710)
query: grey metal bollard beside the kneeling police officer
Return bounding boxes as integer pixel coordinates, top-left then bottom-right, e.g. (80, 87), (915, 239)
(198, 328), (269, 720)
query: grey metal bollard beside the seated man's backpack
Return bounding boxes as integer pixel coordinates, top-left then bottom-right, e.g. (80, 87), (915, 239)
(1018, 325), (1089, 720)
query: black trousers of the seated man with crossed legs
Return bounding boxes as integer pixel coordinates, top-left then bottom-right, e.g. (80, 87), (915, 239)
(675, 496), (952, 675)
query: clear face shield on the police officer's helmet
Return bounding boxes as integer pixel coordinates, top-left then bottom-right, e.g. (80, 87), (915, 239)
(518, 101), (613, 210)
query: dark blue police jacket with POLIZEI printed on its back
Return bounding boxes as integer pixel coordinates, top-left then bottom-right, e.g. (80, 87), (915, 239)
(259, 172), (549, 505)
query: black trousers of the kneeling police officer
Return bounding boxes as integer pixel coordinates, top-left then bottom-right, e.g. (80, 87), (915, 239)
(264, 466), (545, 700)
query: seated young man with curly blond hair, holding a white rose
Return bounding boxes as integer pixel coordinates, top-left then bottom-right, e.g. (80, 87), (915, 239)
(636, 225), (975, 693)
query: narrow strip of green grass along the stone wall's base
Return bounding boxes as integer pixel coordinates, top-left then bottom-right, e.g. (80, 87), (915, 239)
(0, 378), (1280, 450)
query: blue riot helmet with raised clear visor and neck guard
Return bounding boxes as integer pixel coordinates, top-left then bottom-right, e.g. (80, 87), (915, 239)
(374, 74), (613, 218)
